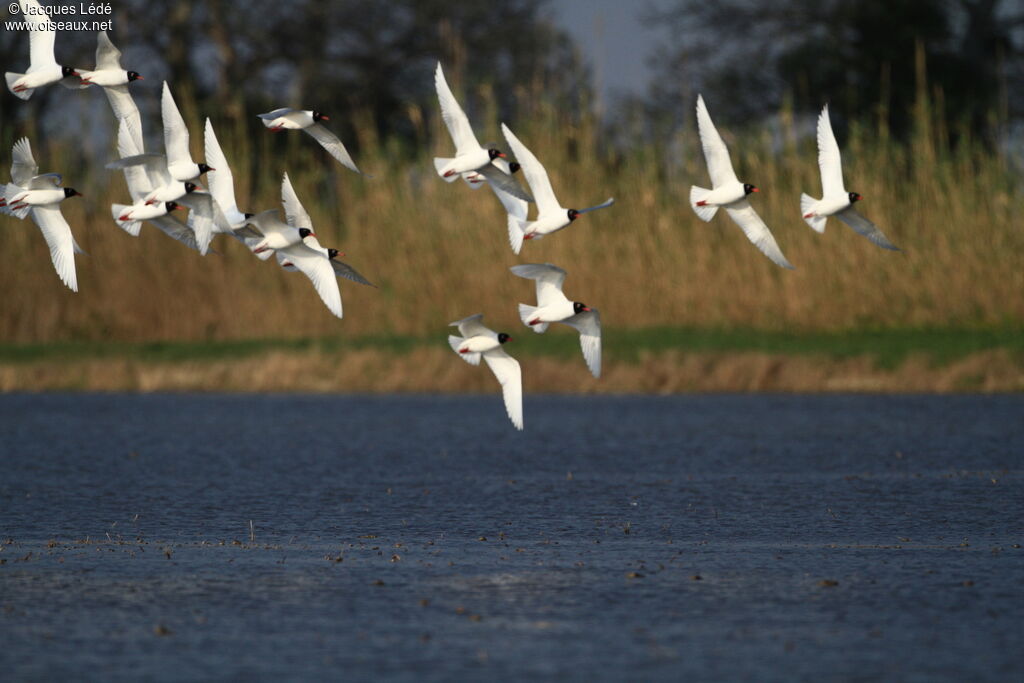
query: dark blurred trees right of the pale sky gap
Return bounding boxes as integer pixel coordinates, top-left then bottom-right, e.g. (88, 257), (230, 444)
(648, 0), (1024, 135)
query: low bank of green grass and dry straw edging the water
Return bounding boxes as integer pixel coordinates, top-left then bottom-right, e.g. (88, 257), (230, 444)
(0, 329), (1024, 393)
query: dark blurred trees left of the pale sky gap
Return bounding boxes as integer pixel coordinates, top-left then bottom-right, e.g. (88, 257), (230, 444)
(0, 0), (589, 153)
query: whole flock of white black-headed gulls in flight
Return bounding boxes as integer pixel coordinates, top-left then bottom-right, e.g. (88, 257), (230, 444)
(0, 0), (897, 430)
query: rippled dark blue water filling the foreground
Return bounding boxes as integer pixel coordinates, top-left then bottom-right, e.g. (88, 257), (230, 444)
(0, 395), (1024, 681)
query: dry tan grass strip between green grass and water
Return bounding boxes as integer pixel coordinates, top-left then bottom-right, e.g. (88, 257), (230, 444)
(0, 347), (1024, 394)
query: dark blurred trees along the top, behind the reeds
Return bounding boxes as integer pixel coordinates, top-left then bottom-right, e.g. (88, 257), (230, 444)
(0, 0), (1024, 150)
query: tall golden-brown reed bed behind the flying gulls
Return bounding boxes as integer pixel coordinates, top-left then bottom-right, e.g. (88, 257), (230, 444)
(0, 81), (1024, 343)
